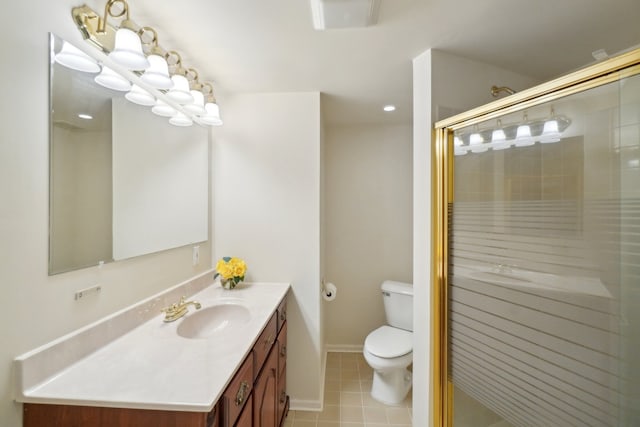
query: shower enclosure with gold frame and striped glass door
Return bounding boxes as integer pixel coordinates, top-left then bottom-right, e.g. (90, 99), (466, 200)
(432, 50), (640, 427)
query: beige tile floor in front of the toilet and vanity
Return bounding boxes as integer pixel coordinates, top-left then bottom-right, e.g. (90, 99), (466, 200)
(284, 353), (412, 427)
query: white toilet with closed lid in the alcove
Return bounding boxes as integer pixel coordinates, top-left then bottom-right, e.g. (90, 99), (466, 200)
(363, 280), (413, 405)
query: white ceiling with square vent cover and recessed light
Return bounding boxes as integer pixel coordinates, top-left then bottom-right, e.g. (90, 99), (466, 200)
(122, 0), (640, 124)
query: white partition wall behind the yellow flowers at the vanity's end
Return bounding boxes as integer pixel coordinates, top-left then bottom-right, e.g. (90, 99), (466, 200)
(213, 92), (323, 409)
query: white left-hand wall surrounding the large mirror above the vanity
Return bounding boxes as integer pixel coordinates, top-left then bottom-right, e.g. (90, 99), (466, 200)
(0, 0), (211, 427)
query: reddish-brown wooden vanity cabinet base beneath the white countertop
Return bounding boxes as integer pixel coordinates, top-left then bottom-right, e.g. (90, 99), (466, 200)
(23, 297), (289, 427)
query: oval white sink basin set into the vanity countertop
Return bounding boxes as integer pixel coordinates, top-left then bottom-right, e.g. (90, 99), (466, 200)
(177, 303), (251, 338)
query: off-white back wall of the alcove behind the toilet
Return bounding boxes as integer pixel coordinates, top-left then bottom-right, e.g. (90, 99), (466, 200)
(323, 125), (413, 351)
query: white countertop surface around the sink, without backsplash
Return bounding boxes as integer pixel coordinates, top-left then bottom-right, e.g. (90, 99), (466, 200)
(16, 283), (289, 412)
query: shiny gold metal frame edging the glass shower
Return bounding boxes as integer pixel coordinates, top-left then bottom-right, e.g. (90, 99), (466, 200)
(431, 49), (640, 427)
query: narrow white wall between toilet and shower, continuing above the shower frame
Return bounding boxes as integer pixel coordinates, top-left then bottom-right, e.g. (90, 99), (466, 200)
(413, 49), (539, 427)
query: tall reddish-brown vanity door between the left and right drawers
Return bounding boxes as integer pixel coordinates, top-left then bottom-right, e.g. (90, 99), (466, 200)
(253, 346), (278, 427)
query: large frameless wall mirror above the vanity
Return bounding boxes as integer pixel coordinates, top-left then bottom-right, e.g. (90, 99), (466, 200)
(49, 34), (209, 275)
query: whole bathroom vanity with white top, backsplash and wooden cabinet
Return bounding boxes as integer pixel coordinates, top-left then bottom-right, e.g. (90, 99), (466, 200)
(14, 272), (289, 427)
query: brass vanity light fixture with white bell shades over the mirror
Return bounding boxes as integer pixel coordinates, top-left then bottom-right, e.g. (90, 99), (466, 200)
(72, 0), (222, 126)
